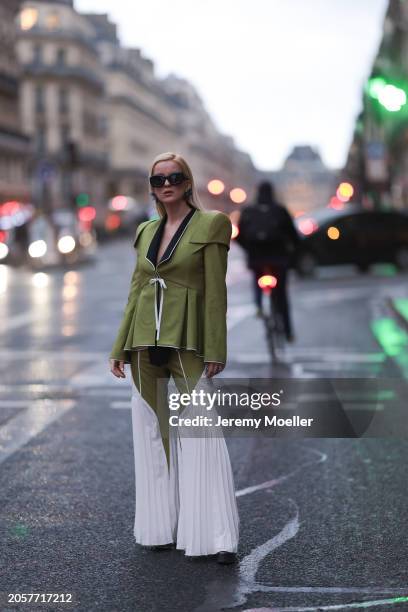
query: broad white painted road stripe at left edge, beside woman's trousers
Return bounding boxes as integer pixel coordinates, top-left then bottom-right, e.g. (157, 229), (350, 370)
(0, 399), (75, 463)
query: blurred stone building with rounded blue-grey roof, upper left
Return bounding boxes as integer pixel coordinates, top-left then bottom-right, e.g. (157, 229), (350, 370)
(17, 0), (108, 220)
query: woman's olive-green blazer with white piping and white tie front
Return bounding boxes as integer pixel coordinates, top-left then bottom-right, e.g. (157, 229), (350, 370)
(110, 209), (232, 364)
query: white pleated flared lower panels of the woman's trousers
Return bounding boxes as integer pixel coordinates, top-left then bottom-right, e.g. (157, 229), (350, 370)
(132, 382), (239, 556)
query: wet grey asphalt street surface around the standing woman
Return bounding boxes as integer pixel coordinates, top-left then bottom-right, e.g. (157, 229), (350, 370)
(0, 242), (408, 612)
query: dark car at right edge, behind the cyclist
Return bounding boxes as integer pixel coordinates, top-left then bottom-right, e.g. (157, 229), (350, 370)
(295, 204), (408, 276)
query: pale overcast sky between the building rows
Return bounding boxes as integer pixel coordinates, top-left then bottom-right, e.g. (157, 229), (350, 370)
(75, 0), (387, 170)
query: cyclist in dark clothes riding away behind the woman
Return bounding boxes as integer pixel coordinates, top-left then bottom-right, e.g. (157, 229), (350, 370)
(237, 181), (300, 342)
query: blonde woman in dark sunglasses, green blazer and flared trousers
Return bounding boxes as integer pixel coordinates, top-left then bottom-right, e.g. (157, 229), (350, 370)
(110, 153), (239, 563)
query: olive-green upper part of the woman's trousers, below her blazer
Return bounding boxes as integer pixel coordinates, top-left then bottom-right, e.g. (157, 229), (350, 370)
(130, 348), (204, 467)
